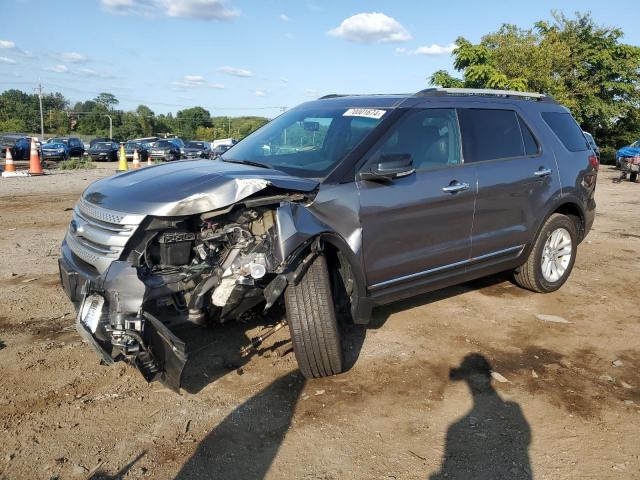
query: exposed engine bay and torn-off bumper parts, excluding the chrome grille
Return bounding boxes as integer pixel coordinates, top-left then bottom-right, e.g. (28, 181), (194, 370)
(70, 189), (320, 390)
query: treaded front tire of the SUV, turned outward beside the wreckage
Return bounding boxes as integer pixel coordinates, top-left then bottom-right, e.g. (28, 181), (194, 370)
(284, 256), (344, 378)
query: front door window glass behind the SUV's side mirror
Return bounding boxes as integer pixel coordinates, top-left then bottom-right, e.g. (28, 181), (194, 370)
(367, 108), (461, 170)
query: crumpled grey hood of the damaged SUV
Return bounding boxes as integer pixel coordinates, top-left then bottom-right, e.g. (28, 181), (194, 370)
(82, 160), (318, 216)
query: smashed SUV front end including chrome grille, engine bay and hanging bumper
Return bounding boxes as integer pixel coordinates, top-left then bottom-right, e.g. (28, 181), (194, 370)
(59, 167), (315, 390)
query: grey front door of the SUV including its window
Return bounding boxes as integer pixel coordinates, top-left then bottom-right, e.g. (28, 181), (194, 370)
(357, 109), (476, 294)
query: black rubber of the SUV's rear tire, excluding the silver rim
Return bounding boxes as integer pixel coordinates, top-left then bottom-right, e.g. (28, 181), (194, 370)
(514, 213), (578, 293)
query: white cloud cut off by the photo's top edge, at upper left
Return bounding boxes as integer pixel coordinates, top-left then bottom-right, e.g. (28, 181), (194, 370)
(102, 0), (240, 20)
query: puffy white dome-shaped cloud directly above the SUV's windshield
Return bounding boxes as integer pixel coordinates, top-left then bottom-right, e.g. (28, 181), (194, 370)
(327, 12), (411, 43)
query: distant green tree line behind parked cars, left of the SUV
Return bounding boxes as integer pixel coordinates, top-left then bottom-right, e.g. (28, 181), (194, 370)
(0, 89), (269, 141)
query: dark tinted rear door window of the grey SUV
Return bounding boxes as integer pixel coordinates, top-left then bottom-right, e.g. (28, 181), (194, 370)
(458, 108), (524, 163)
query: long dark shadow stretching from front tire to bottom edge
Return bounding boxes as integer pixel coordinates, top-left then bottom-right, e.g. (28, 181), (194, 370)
(175, 371), (305, 480)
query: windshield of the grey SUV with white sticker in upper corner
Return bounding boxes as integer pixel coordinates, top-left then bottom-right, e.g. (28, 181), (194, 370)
(221, 104), (386, 178)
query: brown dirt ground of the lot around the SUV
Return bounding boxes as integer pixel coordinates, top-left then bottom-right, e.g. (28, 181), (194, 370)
(0, 165), (640, 480)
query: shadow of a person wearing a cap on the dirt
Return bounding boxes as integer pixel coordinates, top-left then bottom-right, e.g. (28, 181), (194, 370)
(429, 353), (533, 480)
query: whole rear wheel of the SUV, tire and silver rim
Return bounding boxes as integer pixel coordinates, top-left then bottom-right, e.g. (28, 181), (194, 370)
(514, 213), (578, 293)
